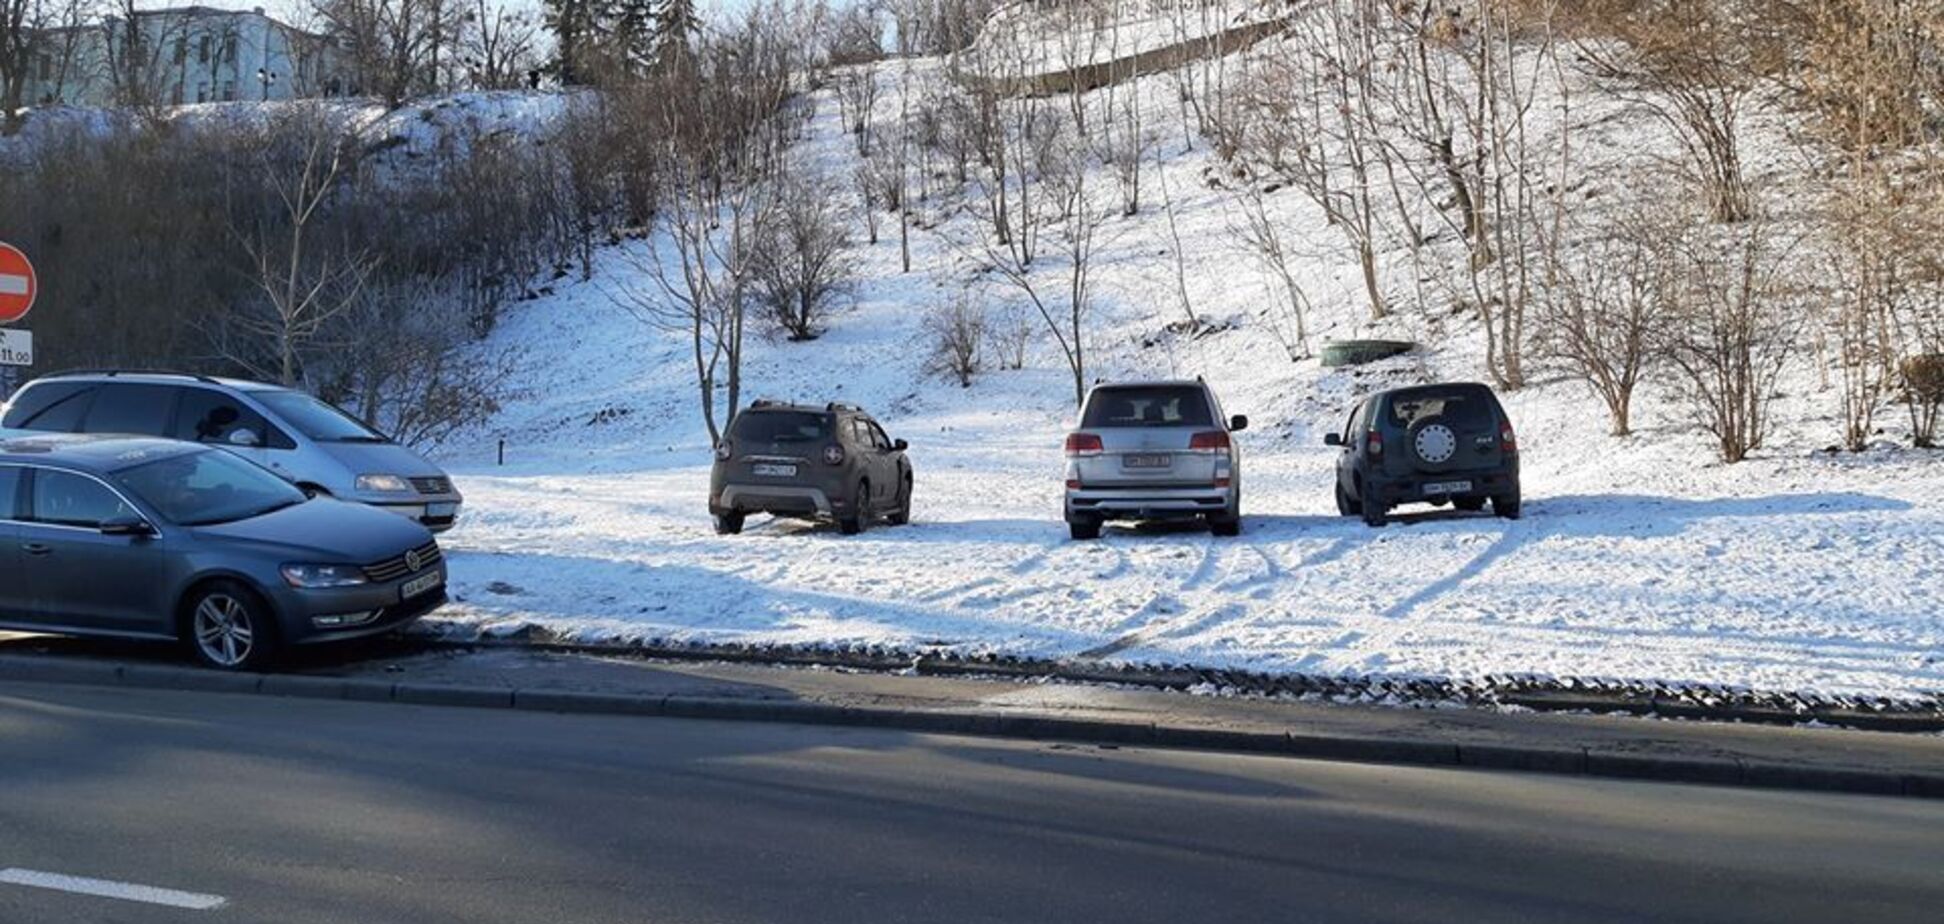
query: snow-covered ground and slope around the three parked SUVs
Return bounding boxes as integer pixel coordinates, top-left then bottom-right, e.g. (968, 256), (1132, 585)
(425, 36), (1944, 696)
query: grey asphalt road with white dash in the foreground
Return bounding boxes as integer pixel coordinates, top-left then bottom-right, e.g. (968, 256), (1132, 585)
(0, 683), (1944, 924)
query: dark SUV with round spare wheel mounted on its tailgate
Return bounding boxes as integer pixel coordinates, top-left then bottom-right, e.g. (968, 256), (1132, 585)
(1324, 383), (1518, 525)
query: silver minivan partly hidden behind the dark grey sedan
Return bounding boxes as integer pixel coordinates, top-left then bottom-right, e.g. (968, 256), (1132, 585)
(0, 370), (463, 533)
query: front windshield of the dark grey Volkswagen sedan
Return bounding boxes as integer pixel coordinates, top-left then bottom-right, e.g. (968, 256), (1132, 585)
(115, 449), (303, 525)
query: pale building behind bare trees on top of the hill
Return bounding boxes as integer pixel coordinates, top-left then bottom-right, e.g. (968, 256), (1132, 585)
(21, 6), (358, 105)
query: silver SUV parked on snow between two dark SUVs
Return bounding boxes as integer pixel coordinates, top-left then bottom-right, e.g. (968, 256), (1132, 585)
(1065, 379), (1248, 539)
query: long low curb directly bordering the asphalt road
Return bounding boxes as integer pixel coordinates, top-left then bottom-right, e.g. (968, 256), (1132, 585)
(0, 656), (1944, 800)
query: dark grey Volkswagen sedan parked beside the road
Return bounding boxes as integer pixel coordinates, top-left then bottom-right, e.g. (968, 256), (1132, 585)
(0, 432), (445, 669)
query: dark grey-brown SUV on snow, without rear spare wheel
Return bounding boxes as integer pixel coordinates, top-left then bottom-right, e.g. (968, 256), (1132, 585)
(710, 401), (912, 535)
